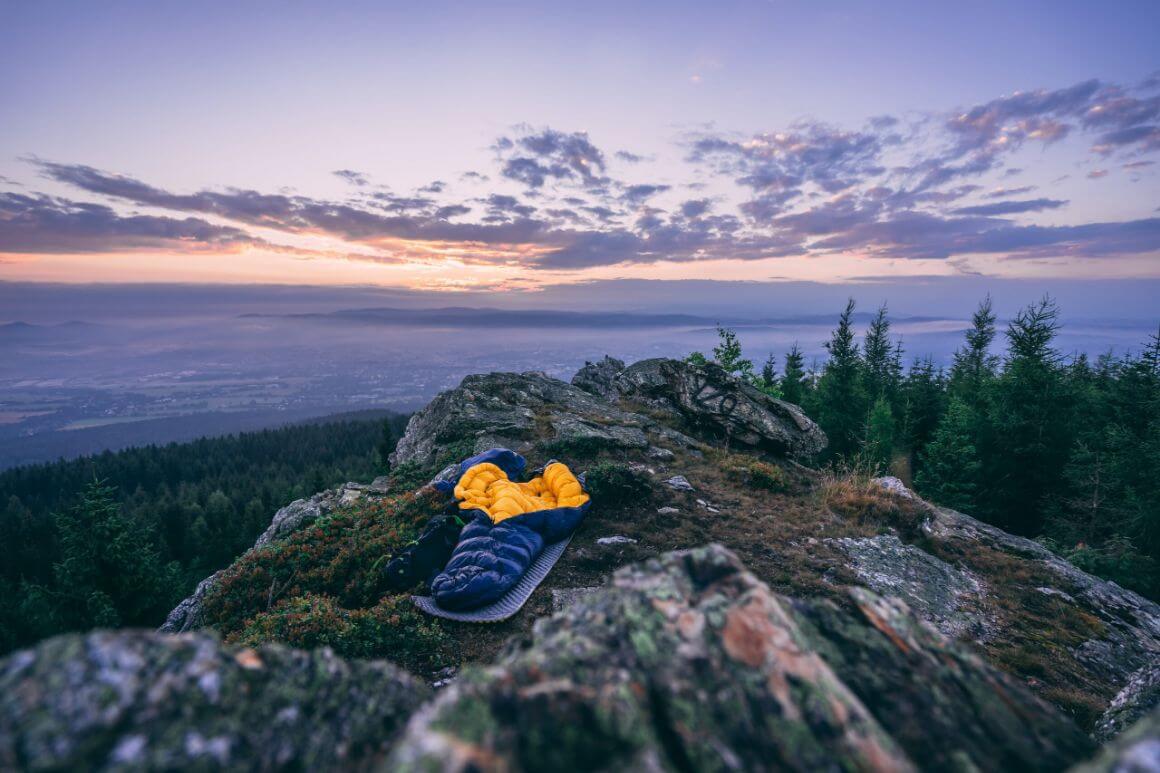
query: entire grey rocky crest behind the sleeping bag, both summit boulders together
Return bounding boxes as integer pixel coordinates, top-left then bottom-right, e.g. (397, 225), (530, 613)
(391, 357), (826, 464)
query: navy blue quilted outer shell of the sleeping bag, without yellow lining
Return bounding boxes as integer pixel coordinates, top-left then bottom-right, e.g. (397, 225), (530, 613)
(430, 449), (590, 612)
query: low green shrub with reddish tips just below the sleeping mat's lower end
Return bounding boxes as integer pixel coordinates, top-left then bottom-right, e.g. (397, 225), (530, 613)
(230, 593), (455, 670)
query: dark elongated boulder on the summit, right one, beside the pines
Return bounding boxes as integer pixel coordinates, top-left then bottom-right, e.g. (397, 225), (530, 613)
(612, 359), (827, 457)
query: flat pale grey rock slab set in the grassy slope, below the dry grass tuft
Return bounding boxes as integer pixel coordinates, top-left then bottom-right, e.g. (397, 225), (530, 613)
(826, 535), (987, 640)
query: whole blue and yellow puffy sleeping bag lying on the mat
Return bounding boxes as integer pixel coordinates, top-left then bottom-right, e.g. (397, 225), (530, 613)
(432, 449), (589, 611)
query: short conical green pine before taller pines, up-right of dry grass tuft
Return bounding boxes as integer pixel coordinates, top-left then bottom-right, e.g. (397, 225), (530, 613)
(914, 397), (981, 513)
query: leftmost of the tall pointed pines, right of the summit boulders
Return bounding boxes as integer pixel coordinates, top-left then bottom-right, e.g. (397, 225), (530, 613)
(817, 298), (867, 457)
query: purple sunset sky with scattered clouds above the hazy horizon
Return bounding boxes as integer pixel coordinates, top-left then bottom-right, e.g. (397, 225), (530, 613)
(0, 0), (1160, 306)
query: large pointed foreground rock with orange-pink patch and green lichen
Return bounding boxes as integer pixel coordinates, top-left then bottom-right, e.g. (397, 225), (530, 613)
(386, 546), (1092, 771)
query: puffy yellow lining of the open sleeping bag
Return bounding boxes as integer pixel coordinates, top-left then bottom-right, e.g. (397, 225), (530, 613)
(455, 462), (588, 523)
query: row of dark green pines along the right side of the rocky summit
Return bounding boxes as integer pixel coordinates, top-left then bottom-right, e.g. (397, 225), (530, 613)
(690, 297), (1160, 599)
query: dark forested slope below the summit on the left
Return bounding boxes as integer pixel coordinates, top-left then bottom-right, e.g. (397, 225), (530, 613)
(0, 414), (406, 652)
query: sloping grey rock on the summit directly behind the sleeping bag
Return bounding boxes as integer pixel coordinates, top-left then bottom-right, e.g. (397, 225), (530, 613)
(391, 373), (696, 464)
